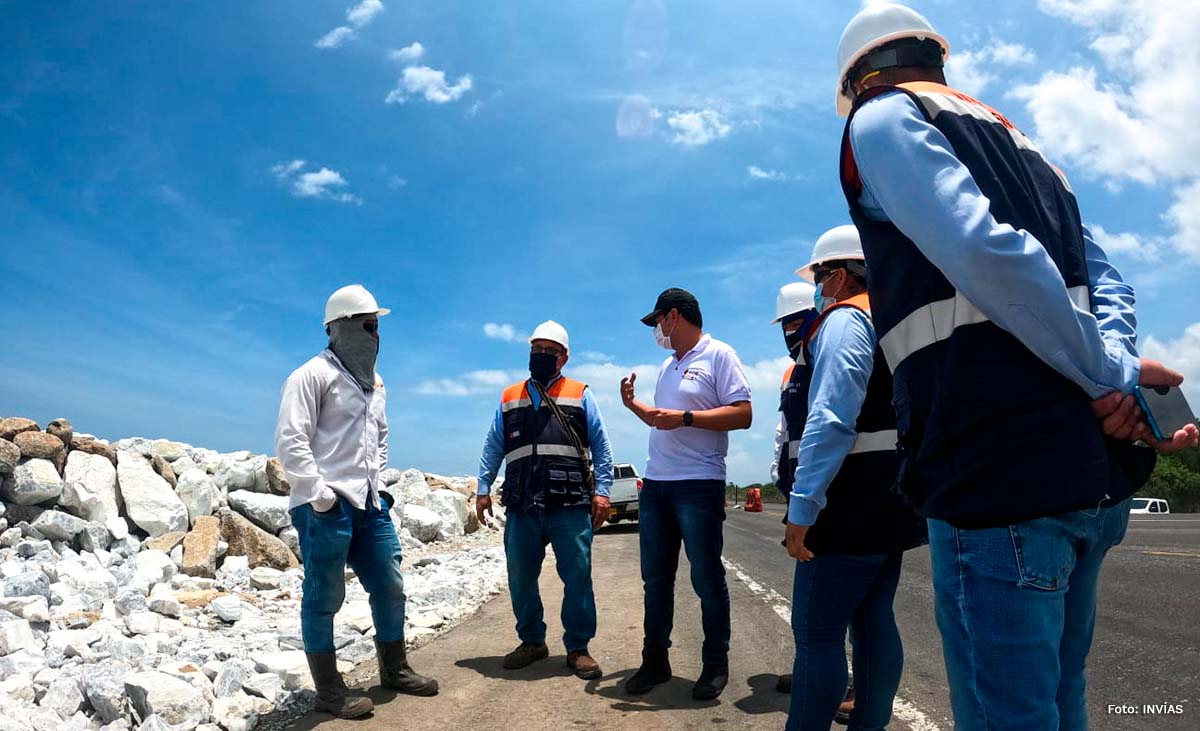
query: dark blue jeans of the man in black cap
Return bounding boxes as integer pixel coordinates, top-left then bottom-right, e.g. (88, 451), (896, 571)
(637, 480), (730, 665)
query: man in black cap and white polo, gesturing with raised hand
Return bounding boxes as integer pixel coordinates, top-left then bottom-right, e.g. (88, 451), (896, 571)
(620, 288), (751, 700)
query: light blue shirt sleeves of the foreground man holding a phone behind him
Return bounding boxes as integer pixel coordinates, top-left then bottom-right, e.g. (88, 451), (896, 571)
(850, 92), (1140, 399)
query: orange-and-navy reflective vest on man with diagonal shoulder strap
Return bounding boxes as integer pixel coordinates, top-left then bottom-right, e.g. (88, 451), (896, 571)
(500, 378), (592, 510)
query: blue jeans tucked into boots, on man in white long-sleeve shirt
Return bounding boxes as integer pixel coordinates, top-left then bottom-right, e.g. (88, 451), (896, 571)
(292, 498), (406, 653)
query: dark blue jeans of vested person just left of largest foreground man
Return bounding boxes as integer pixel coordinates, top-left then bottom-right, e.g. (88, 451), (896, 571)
(786, 552), (904, 731)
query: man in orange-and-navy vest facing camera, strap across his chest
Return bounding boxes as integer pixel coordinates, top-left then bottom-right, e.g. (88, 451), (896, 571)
(475, 320), (612, 679)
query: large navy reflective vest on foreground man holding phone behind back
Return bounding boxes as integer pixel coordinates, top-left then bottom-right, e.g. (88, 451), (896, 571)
(841, 82), (1153, 528)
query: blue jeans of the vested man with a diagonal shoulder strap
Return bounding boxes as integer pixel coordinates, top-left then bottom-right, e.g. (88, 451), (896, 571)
(504, 505), (596, 652)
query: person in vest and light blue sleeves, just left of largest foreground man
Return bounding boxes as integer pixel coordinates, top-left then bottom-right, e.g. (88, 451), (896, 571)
(785, 226), (928, 731)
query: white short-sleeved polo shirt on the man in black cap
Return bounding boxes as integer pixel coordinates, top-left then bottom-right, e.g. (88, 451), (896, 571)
(646, 335), (750, 480)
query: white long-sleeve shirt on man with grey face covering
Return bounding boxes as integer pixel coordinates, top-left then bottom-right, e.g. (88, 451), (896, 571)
(275, 348), (388, 510)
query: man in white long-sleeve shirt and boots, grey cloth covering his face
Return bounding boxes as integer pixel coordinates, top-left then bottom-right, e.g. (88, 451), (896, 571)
(275, 284), (438, 718)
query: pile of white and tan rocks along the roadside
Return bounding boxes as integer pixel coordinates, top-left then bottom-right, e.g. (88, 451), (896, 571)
(0, 418), (504, 731)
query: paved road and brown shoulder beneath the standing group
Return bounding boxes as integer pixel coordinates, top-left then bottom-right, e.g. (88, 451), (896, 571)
(287, 505), (1200, 731)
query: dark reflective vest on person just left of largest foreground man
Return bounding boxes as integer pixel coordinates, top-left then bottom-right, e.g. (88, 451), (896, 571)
(780, 294), (928, 556)
